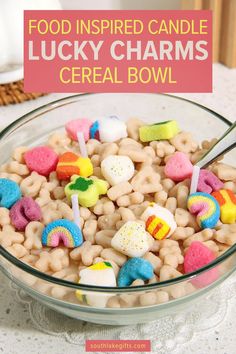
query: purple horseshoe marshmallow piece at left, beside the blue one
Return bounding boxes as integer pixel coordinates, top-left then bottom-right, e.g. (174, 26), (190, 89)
(10, 197), (42, 231)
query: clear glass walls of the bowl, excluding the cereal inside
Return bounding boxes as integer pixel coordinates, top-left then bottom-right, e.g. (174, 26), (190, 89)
(0, 93), (236, 325)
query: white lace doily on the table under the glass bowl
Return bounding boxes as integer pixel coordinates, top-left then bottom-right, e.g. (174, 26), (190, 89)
(11, 276), (236, 354)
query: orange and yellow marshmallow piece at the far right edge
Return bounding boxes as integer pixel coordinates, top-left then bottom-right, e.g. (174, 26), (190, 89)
(212, 189), (236, 224)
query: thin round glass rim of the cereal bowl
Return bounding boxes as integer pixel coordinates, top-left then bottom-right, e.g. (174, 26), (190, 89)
(0, 93), (236, 294)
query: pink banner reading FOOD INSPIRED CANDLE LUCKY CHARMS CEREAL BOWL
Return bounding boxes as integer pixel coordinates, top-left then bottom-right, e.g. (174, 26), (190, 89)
(24, 10), (212, 93)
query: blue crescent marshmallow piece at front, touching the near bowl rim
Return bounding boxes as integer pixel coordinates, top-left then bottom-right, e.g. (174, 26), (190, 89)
(117, 257), (154, 287)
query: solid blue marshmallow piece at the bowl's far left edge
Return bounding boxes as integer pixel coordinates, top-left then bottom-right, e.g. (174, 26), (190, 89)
(0, 178), (21, 209)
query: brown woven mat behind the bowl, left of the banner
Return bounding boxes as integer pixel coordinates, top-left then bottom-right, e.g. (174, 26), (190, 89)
(0, 80), (45, 106)
